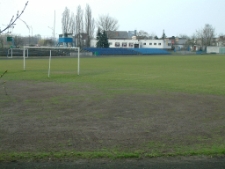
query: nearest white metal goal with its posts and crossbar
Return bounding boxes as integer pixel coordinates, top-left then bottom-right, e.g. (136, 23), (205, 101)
(23, 46), (80, 77)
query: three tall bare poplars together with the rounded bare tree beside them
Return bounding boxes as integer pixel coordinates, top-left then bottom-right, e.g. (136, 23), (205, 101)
(62, 4), (118, 47)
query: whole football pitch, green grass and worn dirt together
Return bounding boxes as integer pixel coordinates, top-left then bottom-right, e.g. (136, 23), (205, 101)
(0, 55), (225, 161)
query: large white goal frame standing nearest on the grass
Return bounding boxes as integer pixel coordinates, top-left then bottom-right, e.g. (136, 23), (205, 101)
(23, 46), (80, 77)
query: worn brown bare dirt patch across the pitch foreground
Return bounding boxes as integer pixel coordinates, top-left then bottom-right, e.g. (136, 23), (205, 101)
(0, 81), (225, 153)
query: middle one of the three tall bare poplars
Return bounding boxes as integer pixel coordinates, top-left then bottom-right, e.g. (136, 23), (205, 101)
(76, 5), (84, 47)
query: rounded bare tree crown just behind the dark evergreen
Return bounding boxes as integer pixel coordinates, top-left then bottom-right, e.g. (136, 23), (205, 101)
(96, 15), (119, 31)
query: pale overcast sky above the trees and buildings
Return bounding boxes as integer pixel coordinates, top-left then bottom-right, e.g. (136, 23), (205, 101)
(0, 0), (225, 37)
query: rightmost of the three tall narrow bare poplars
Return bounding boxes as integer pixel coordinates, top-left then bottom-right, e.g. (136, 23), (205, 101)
(85, 4), (95, 47)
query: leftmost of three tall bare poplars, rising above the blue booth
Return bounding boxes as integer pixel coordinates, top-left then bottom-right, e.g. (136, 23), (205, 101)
(62, 7), (75, 36)
